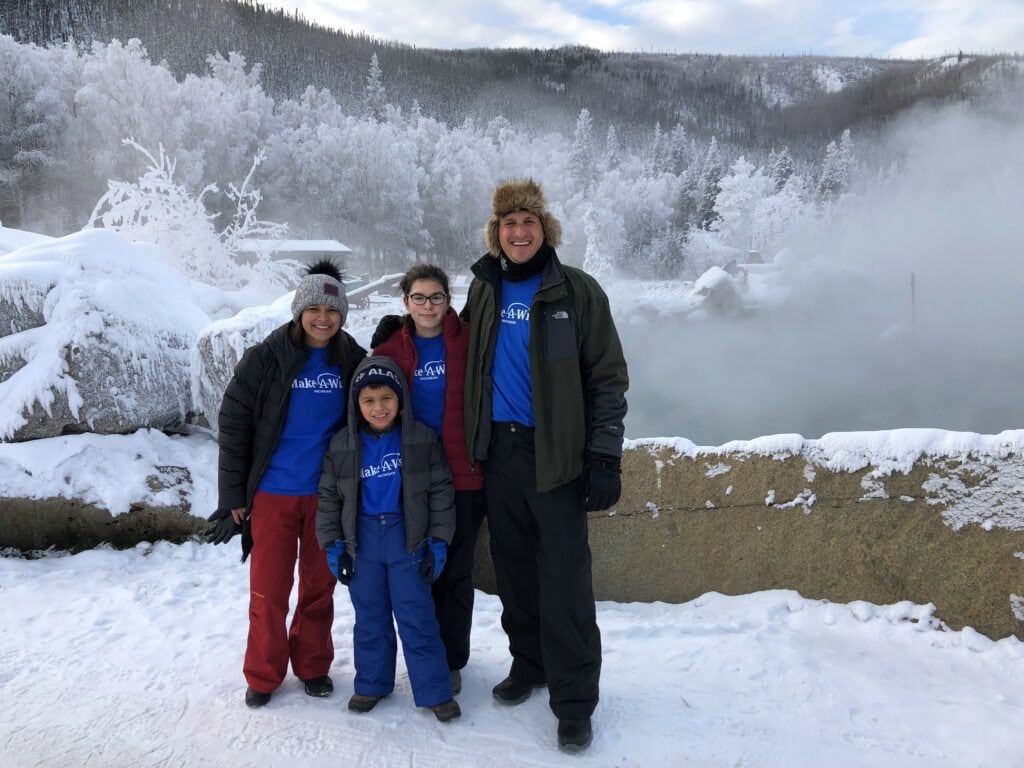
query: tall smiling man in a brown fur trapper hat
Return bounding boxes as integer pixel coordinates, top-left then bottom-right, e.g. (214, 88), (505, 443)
(463, 180), (629, 752)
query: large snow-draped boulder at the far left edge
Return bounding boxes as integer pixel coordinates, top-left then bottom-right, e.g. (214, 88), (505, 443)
(0, 229), (209, 441)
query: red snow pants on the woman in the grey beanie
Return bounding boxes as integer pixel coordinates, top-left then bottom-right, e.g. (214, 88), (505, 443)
(243, 490), (337, 693)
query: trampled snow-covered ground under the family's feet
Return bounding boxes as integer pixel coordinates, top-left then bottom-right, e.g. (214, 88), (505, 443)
(0, 540), (1024, 768)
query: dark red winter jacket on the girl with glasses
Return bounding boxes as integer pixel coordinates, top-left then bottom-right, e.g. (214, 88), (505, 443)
(374, 307), (483, 490)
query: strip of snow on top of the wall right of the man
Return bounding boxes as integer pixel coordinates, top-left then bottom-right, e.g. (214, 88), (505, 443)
(623, 428), (1024, 475)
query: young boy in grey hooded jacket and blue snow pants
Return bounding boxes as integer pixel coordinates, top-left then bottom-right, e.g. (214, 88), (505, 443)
(316, 357), (462, 723)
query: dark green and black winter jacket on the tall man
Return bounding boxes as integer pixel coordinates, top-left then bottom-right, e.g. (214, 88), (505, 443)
(463, 250), (629, 493)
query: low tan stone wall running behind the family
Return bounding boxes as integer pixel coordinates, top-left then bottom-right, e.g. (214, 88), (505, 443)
(0, 441), (1024, 639)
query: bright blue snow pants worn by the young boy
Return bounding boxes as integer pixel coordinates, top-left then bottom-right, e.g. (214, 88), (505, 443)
(348, 514), (452, 707)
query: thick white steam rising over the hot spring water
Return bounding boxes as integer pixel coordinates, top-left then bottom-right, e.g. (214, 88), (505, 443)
(608, 100), (1024, 445)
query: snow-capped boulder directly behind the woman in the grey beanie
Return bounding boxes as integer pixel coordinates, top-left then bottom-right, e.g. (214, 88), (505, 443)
(191, 291), (295, 432)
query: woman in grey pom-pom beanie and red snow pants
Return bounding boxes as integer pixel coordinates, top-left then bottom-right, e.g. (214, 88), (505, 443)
(209, 261), (367, 707)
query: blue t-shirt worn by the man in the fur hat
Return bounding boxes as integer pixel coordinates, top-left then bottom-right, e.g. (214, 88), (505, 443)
(490, 272), (541, 427)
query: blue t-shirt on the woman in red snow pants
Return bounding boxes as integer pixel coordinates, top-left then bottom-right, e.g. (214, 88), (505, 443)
(259, 347), (345, 496)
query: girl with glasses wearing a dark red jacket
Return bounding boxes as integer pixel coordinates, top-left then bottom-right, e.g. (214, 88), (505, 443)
(374, 264), (484, 693)
